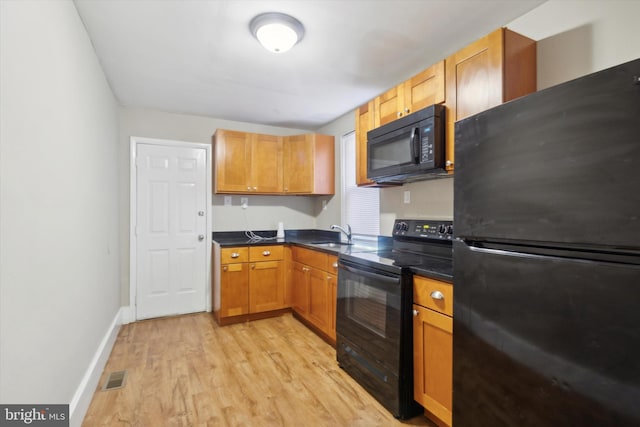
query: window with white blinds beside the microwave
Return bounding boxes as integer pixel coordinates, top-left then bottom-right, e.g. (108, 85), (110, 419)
(341, 132), (380, 236)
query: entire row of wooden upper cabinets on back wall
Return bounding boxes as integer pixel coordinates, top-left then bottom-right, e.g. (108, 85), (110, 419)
(213, 129), (335, 195)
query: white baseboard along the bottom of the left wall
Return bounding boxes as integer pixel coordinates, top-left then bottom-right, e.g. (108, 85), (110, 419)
(69, 307), (129, 427)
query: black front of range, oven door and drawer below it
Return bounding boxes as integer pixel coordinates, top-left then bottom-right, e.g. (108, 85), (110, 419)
(336, 259), (404, 416)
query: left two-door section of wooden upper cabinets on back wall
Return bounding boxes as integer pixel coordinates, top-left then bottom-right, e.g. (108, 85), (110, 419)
(214, 129), (283, 194)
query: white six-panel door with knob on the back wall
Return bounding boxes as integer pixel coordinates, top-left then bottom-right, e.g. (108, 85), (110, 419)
(135, 144), (211, 319)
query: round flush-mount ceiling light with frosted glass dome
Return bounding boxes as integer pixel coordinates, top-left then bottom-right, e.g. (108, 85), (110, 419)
(249, 12), (304, 53)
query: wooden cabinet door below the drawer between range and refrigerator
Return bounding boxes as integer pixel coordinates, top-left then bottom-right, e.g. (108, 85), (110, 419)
(413, 304), (453, 426)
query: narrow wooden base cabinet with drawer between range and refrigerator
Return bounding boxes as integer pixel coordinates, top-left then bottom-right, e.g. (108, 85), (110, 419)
(413, 276), (453, 426)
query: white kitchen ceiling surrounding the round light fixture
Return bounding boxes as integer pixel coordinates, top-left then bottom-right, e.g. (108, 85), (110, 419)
(75, 0), (544, 130)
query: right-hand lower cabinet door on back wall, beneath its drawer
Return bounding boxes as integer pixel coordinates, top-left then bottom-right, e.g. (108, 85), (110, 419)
(249, 261), (285, 313)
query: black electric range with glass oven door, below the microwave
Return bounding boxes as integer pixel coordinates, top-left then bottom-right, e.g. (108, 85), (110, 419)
(336, 220), (453, 419)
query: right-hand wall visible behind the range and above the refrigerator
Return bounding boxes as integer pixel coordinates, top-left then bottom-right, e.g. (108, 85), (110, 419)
(372, 0), (640, 235)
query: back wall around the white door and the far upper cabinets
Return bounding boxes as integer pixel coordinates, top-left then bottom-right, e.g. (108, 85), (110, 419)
(119, 108), (317, 306)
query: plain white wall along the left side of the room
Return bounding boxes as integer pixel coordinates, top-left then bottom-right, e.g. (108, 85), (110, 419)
(0, 1), (120, 422)
